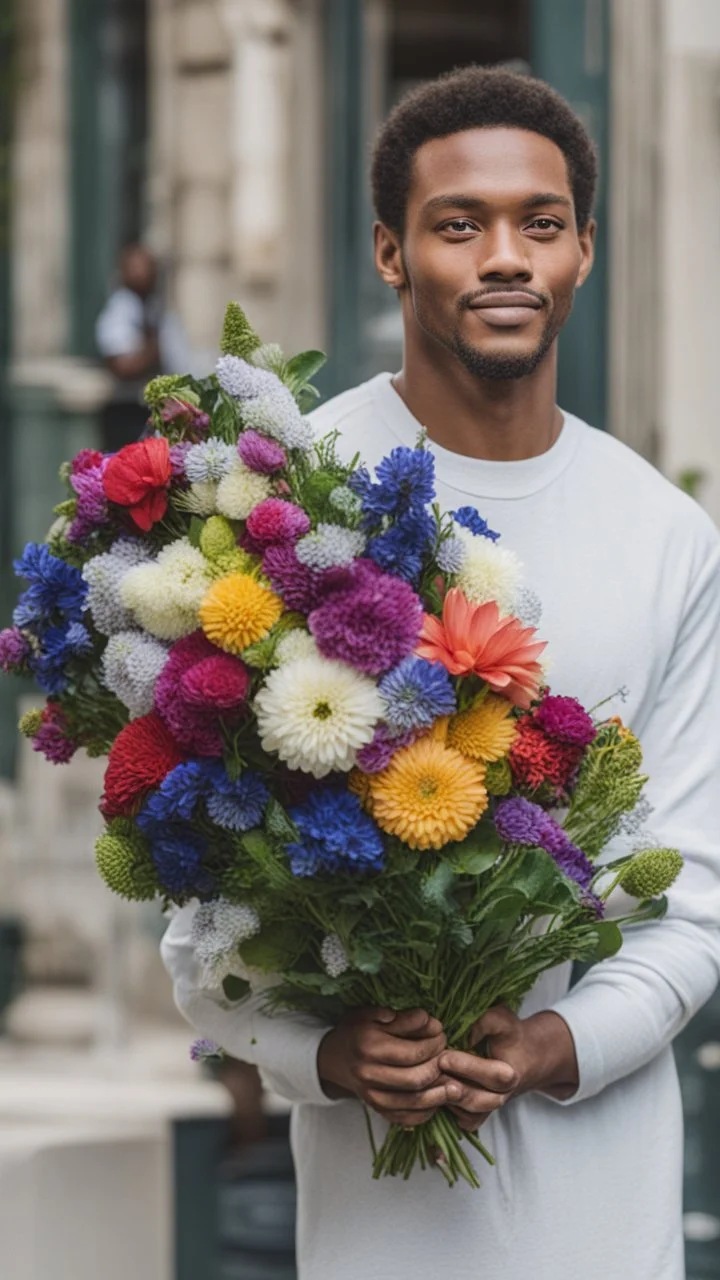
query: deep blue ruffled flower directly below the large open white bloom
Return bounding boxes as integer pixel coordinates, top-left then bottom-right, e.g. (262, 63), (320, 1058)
(287, 787), (384, 876)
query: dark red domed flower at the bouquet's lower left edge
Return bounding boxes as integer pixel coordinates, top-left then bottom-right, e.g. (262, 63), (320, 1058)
(100, 712), (184, 818)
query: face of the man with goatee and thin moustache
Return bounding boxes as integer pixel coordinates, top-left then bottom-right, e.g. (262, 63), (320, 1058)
(375, 128), (594, 379)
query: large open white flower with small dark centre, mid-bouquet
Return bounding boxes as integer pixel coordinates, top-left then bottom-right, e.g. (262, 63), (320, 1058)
(255, 657), (383, 778)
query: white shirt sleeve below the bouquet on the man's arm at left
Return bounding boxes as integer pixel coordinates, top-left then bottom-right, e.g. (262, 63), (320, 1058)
(160, 905), (336, 1106)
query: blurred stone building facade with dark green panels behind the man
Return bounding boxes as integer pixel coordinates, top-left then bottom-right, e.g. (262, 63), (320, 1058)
(0, 0), (720, 1275)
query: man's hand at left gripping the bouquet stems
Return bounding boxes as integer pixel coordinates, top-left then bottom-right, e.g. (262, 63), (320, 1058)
(318, 1009), (448, 1126)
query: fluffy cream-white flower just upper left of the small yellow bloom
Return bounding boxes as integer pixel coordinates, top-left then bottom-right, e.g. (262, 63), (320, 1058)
(120, 538), (213, 640)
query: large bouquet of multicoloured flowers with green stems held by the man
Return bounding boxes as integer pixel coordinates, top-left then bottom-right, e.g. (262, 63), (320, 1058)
(0, 303), (682, 1185)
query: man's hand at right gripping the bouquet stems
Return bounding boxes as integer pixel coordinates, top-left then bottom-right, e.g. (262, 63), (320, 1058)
(439, 1007), (578, 1130)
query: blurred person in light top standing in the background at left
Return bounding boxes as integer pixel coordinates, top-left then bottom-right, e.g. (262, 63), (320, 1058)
(95, 244), (193, 453)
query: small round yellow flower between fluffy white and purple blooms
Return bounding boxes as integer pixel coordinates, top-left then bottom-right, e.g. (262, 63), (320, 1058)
(200, 573), (283, 654)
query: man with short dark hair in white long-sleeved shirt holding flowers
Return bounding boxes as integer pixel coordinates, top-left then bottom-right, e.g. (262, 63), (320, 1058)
(164, 68), (720, 1280)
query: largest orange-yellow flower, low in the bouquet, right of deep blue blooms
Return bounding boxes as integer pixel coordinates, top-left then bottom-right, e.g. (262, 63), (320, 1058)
(369, 737), (488, 849)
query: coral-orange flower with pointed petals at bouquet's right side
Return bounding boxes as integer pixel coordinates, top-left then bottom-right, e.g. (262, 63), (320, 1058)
(415, 586), (546, 709)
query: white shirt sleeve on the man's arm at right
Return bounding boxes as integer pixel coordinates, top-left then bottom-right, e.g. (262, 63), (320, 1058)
(552, 530), (720, 1105)
